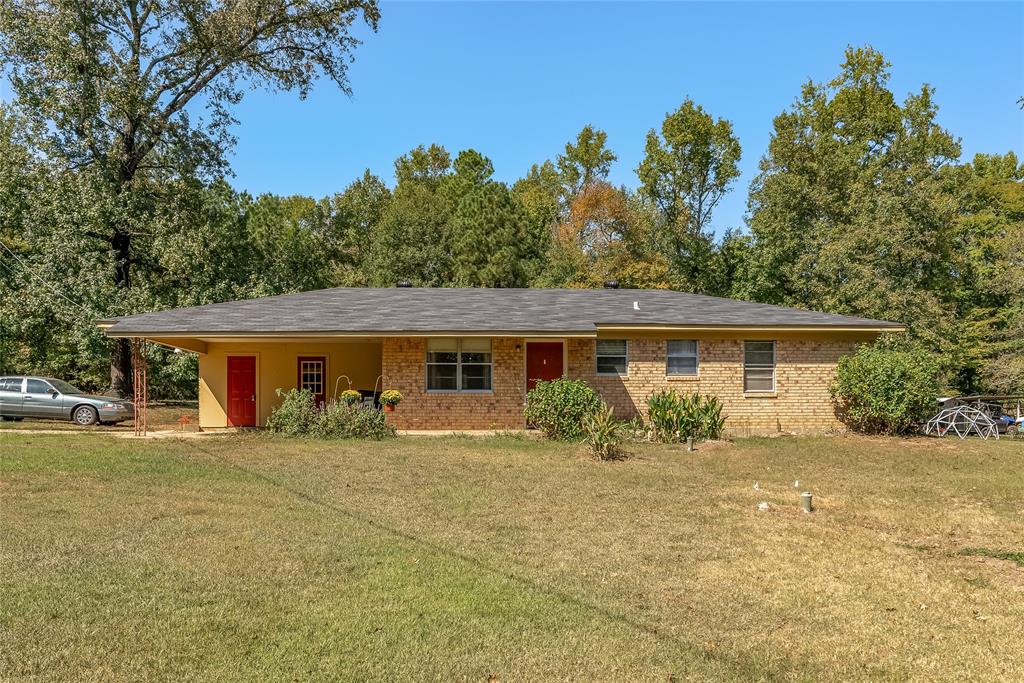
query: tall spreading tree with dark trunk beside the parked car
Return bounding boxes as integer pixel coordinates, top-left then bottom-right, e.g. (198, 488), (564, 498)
(0, 0), (379, 394)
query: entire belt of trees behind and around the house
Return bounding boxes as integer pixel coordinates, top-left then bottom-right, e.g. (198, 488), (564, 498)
(0, 40), (1024, 396)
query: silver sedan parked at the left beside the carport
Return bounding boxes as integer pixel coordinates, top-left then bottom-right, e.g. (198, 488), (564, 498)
(0, 377), (135, 426)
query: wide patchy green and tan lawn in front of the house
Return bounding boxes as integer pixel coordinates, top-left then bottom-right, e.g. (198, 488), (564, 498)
(0, 431), (1024, 681)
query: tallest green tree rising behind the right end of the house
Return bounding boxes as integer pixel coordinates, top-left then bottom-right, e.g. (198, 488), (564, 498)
(744, 47), (959, 374)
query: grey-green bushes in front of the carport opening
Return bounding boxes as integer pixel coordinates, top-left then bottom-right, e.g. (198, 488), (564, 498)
(266, 389), (395, 439)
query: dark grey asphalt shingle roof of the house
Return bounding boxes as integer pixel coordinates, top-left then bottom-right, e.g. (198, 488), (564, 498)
(99, 288), (902, 336)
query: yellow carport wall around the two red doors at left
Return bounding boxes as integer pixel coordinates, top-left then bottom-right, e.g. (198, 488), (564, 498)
(199, 341), (381, 429)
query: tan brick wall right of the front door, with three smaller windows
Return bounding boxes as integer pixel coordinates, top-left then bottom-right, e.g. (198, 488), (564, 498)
(567, 338), (857, 434)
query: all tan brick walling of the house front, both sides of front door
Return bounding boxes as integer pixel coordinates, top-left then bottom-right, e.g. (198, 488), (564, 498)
(382, 337), (857, 434)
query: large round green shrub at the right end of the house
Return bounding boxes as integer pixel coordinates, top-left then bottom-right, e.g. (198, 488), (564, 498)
(829, 342), (939, 434)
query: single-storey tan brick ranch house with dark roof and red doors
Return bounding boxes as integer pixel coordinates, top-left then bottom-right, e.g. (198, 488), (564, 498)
(99, 287), (903, 433)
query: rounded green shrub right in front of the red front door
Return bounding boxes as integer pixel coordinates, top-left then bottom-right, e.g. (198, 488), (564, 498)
(523, 379), (601, 441)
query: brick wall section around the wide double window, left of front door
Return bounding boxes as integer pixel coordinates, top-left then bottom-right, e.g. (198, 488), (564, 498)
(382, 337), (526, 429)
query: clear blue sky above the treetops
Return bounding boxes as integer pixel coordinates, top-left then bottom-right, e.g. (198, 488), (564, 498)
(8, 1), (1024, 231)
